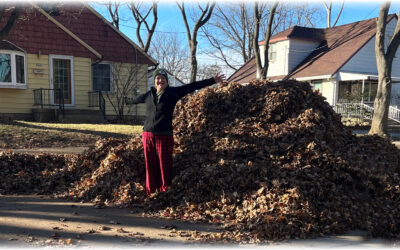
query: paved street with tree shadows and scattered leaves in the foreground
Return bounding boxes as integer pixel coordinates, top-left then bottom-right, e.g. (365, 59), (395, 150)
(0, 195), (399, 249)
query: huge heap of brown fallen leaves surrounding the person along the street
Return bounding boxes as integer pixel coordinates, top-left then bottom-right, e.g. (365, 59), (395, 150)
(0, 81), (400, 242)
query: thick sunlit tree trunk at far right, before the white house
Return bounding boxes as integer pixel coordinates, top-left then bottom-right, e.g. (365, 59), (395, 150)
(369, 2), (400, 137)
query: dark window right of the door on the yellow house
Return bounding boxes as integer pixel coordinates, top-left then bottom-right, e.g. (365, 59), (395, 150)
(92, 63), (112, 92)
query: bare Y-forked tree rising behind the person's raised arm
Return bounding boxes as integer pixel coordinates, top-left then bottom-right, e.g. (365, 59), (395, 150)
(177, 2), (215, 82)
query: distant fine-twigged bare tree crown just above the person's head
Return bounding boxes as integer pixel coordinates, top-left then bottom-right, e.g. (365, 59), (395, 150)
(149, 33), (190, 81)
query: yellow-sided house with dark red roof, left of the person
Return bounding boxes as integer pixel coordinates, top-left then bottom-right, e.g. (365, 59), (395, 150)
(0, 3), (157, 122)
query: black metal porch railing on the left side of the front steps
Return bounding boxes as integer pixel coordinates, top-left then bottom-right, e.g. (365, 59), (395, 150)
(33, 88), (65, 115)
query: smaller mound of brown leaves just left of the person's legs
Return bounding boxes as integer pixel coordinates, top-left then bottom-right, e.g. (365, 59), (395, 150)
(59, 137), (146, 206)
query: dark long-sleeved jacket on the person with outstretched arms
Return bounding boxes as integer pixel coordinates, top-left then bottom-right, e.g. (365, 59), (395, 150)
(125, 78), (215, 133)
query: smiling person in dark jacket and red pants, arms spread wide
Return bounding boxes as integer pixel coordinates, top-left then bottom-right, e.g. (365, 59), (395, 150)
(124, 68), (225, 196)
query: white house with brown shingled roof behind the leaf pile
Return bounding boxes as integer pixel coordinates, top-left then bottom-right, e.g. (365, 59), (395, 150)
(228, 14), (400, 109)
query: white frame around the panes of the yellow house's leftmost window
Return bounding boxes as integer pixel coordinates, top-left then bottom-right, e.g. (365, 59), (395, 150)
(0, 50), (28, 89)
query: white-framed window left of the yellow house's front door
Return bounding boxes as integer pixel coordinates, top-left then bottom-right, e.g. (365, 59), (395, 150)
(0, 50), (26, 86)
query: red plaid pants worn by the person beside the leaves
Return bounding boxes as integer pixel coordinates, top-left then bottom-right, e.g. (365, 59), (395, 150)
(142, 132), (174, 195)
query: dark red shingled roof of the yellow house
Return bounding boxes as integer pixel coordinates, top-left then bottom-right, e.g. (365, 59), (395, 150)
(0, 3), (156, 66)
